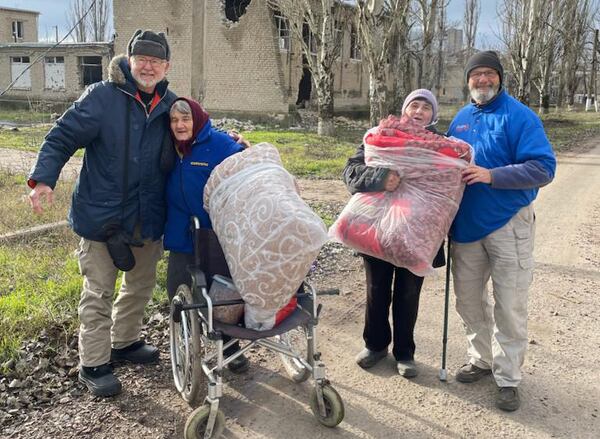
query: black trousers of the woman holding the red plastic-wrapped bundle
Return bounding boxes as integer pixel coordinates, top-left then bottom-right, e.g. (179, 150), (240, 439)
(363, 255), (423, 361)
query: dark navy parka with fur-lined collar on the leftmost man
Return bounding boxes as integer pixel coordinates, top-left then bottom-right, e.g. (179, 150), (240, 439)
(29, 56), (176, 241)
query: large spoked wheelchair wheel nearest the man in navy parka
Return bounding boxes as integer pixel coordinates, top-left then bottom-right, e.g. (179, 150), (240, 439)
(170, 285), (205, 406)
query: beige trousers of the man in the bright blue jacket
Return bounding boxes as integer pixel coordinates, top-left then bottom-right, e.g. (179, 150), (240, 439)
(451, 205), (535, 387)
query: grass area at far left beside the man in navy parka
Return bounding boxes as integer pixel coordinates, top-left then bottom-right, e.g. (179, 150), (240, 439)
(0, 172), (167, 373)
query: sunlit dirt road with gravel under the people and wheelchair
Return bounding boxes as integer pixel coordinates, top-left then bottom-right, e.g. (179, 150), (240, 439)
(0, 139), (600, 439)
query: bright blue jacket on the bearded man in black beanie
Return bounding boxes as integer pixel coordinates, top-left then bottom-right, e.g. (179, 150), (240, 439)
(448, 90), (556, 242)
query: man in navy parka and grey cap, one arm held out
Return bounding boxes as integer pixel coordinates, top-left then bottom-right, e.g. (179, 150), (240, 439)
(27, 30), (176, 396)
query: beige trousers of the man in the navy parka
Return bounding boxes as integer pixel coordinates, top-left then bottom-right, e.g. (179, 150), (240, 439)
(78, 238), (162, 367)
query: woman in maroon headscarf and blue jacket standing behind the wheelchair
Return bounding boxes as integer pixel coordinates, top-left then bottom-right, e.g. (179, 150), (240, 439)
(164, 98), (249, 373)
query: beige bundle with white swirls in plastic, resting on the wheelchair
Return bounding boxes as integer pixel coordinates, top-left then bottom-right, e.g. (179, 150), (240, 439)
(204, 143), (327, 330)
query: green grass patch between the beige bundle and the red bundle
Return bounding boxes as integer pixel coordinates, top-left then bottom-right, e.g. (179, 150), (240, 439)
(243, 131), (356, 178)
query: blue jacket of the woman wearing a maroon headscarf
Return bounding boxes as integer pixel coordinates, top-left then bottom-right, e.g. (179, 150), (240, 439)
(164, 120), (243, 253)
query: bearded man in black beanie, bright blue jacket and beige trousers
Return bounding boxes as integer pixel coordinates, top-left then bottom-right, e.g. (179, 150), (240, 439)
(448, 51), (556, 411)
